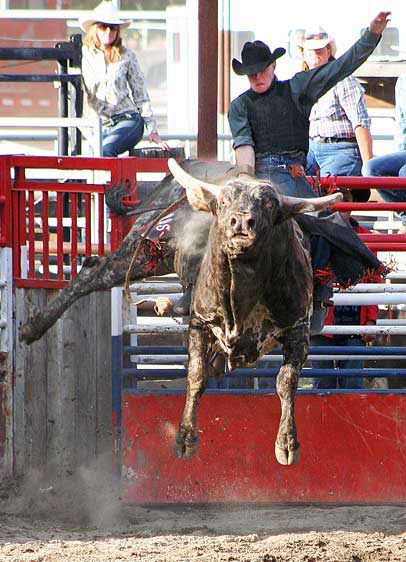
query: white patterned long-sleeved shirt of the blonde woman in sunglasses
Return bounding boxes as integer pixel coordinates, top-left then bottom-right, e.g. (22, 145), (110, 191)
(82, 46), (156, 132)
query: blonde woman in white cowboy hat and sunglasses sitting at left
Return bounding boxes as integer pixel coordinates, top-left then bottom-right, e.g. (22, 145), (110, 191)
(80, 1), (169, 156)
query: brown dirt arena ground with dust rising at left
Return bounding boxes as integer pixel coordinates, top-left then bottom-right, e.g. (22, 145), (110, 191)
(0, 469), (406, 562)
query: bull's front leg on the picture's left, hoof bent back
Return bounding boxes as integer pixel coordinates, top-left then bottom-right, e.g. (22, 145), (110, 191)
(173, 318), (210, 458)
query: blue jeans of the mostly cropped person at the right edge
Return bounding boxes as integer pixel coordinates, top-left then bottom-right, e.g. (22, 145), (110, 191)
(362, 150), (406, 225)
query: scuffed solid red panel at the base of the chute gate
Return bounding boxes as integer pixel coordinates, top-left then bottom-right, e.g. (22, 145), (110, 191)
(122, 394), (406, 503)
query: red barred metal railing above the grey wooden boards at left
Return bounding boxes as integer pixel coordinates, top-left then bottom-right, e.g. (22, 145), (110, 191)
(0, 156), (168, 289)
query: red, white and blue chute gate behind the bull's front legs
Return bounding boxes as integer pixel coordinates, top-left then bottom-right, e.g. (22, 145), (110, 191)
(112, 178), (406, 503)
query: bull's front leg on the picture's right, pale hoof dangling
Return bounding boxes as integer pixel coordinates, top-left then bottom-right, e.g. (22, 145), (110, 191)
(275, 322), (309, 464)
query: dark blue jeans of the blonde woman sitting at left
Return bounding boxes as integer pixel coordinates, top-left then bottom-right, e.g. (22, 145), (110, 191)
(103, 112), (144, 157)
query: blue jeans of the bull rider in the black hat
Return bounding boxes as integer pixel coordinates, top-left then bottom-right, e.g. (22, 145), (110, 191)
(255, 153), (318, 198)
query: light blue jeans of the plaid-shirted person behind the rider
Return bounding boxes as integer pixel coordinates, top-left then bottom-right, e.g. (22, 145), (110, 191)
(306, 139), (362, 176)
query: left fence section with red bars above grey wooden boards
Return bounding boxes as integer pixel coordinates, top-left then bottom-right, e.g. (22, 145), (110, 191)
(0, 156), (171, 478)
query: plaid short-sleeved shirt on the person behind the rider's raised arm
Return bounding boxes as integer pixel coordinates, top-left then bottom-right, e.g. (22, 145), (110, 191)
(309, 76), (371, 138)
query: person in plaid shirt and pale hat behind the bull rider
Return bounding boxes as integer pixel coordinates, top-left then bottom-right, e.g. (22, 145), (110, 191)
(298, 26), (372, 202)
